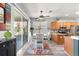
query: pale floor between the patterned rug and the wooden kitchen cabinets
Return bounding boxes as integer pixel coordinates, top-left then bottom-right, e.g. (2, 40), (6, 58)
(50, 42), (67, 56)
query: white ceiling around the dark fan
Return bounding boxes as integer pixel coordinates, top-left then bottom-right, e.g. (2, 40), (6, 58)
(17, 3), (79, 18)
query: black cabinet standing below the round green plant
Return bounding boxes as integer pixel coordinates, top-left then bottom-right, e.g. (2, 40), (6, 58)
(0, 39), (16, 56)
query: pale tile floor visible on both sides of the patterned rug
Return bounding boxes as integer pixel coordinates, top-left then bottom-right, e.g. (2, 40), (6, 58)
(17, 41), (67, 56)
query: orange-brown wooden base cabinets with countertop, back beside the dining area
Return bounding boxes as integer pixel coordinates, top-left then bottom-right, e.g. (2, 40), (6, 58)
(51, 32), (66, 45)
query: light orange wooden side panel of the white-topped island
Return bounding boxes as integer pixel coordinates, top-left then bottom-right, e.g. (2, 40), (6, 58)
(64, 36), (73, 55)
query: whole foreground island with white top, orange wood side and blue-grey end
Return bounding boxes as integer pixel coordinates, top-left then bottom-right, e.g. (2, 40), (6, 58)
(64, 36), (79, 56)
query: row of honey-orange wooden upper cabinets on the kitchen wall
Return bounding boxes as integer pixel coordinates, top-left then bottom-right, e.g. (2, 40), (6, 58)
(50, 22), (78, 29)
